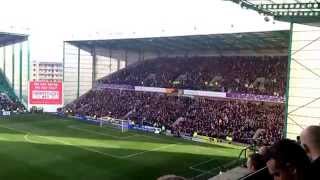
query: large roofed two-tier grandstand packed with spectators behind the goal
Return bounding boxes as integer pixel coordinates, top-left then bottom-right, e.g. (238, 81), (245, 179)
(63, 30), (289, 179)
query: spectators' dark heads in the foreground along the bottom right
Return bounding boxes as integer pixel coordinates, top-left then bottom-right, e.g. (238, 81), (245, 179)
(159, 125), (320, 180)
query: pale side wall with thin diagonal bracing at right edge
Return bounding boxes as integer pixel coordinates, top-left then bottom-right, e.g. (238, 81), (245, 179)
(285, 24), (320, 139)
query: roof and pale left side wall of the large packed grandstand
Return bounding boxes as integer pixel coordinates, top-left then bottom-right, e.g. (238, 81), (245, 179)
(64, 31), (289, 103)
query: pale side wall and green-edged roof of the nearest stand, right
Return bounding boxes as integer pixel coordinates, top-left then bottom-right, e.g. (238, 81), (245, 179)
(230, 0), (320, 139)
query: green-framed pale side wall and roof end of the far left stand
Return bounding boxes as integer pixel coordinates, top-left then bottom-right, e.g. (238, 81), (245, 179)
(0, 32), (30, 106)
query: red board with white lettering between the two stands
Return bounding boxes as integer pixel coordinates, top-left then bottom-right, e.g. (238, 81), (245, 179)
(29, 81), (63, 105)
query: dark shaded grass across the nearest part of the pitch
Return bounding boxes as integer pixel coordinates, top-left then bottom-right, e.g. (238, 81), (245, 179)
(0, 141), (238, 180)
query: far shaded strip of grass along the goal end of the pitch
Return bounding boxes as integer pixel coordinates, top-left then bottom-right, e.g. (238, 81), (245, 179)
(0, 114), (241, 150)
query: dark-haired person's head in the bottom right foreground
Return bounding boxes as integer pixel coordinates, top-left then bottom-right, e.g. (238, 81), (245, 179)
(267, 139), (310, 180)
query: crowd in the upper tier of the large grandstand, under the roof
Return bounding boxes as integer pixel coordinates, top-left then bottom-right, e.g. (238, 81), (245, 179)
(99, 56), (287, 96)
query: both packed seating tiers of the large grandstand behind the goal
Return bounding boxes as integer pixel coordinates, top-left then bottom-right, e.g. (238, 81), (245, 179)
(66, 56), (287, 144)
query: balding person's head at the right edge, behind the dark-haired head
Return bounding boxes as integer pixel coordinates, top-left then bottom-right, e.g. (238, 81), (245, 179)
(300, 126), (320, 161)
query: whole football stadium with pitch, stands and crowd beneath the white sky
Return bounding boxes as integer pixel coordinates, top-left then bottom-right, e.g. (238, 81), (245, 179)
(0, 0), (320, 180)
